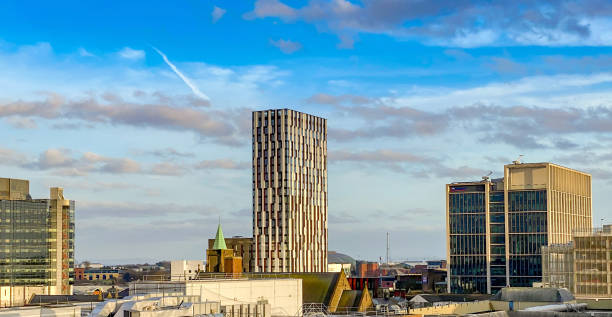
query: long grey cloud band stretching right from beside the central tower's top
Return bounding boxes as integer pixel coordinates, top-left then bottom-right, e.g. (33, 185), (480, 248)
(329, 96), (612, 149)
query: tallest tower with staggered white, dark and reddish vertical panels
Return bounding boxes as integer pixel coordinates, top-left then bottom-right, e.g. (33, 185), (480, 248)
(253, 109), (327, 272)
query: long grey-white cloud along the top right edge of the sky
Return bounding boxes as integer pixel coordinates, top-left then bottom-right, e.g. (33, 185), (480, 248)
(244, 0), (612, 47)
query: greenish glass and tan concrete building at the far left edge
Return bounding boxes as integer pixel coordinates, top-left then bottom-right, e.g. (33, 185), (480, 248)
(0, 178), (75, 306)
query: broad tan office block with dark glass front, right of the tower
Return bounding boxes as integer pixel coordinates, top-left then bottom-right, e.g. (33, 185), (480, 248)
(446, 162), (592, 293)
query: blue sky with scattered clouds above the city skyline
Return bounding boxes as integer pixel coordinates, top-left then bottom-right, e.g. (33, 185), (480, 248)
(0, 0), (612, 264)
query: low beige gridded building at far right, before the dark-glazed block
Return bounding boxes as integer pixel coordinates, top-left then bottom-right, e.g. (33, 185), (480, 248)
(542, 225), (612, 298)
